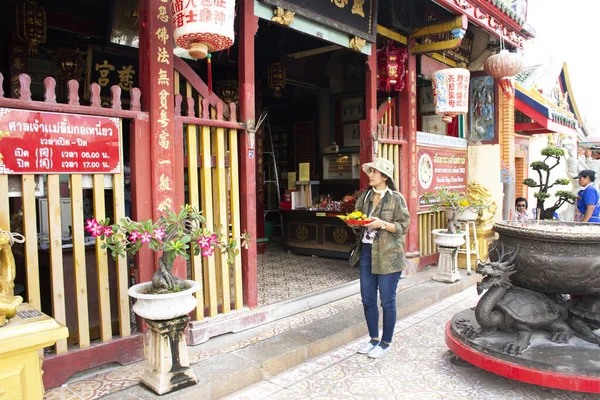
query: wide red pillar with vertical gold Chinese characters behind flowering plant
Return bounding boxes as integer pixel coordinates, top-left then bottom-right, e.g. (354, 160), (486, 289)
(138, 0), (186, 278)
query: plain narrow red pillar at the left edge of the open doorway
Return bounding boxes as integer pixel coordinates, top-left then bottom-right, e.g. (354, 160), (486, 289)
(238, 0), (258, 307)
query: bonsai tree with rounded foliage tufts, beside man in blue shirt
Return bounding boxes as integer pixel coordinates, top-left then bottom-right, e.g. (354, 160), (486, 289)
(523, 146), (577, 219)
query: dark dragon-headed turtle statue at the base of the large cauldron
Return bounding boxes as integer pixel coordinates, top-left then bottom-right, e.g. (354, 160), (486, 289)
(462, 246), (573, 354)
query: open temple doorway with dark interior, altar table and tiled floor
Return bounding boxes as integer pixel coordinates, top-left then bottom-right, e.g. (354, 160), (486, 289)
(256, 21), (366, 305)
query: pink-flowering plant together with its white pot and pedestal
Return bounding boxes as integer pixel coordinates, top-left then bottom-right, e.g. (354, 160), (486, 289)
(86, 205), (249, 394)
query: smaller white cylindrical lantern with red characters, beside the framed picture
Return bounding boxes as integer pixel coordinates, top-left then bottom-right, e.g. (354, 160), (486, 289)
(432, 68), (471, 124)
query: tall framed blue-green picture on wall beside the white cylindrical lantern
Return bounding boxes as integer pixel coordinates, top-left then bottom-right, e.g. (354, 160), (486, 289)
(469, 75), (498, 144)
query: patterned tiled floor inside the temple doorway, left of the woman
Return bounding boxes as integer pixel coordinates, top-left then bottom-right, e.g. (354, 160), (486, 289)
(258, 240), (359, 306)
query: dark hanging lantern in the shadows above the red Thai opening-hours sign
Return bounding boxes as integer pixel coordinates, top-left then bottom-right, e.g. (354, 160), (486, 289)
(17, 0), (48, 56)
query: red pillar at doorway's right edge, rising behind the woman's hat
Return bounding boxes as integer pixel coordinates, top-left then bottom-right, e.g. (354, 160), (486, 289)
(360, 49), (379, 189)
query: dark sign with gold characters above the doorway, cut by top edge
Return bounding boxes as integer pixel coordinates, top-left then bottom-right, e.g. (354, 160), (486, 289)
(261, 0), (377, 43)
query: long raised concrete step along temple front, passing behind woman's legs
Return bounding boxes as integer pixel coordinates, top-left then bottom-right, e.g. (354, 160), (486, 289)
(99, 270), (478, 400)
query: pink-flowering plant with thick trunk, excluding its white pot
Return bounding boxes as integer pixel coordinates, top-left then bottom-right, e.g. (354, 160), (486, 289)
(85, 205), (250, 294)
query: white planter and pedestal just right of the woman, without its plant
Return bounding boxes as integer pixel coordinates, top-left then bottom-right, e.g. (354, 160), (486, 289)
(431, 229), (465, 283)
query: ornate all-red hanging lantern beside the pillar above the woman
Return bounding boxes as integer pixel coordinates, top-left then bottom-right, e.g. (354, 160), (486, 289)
(377, 43), (408, 93)
